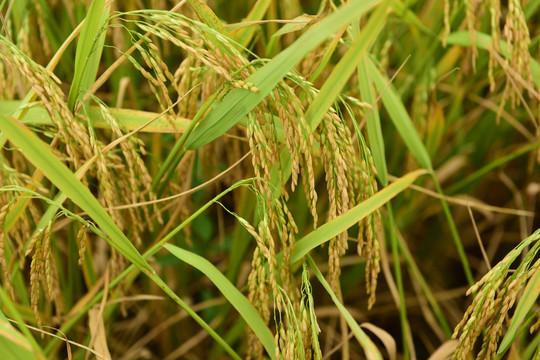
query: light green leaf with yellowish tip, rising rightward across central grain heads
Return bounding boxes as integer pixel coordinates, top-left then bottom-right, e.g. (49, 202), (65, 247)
(291, 170), (427, 263)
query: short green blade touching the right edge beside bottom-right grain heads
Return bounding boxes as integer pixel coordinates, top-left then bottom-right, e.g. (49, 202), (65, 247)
(497, 269), (540, 355)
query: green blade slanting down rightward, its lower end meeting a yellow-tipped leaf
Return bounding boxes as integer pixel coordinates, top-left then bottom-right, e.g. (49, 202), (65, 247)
(368, 59), (433, 170)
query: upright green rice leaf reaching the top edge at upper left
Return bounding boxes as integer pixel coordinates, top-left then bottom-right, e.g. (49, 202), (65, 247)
(68, 0), (109, 111)
